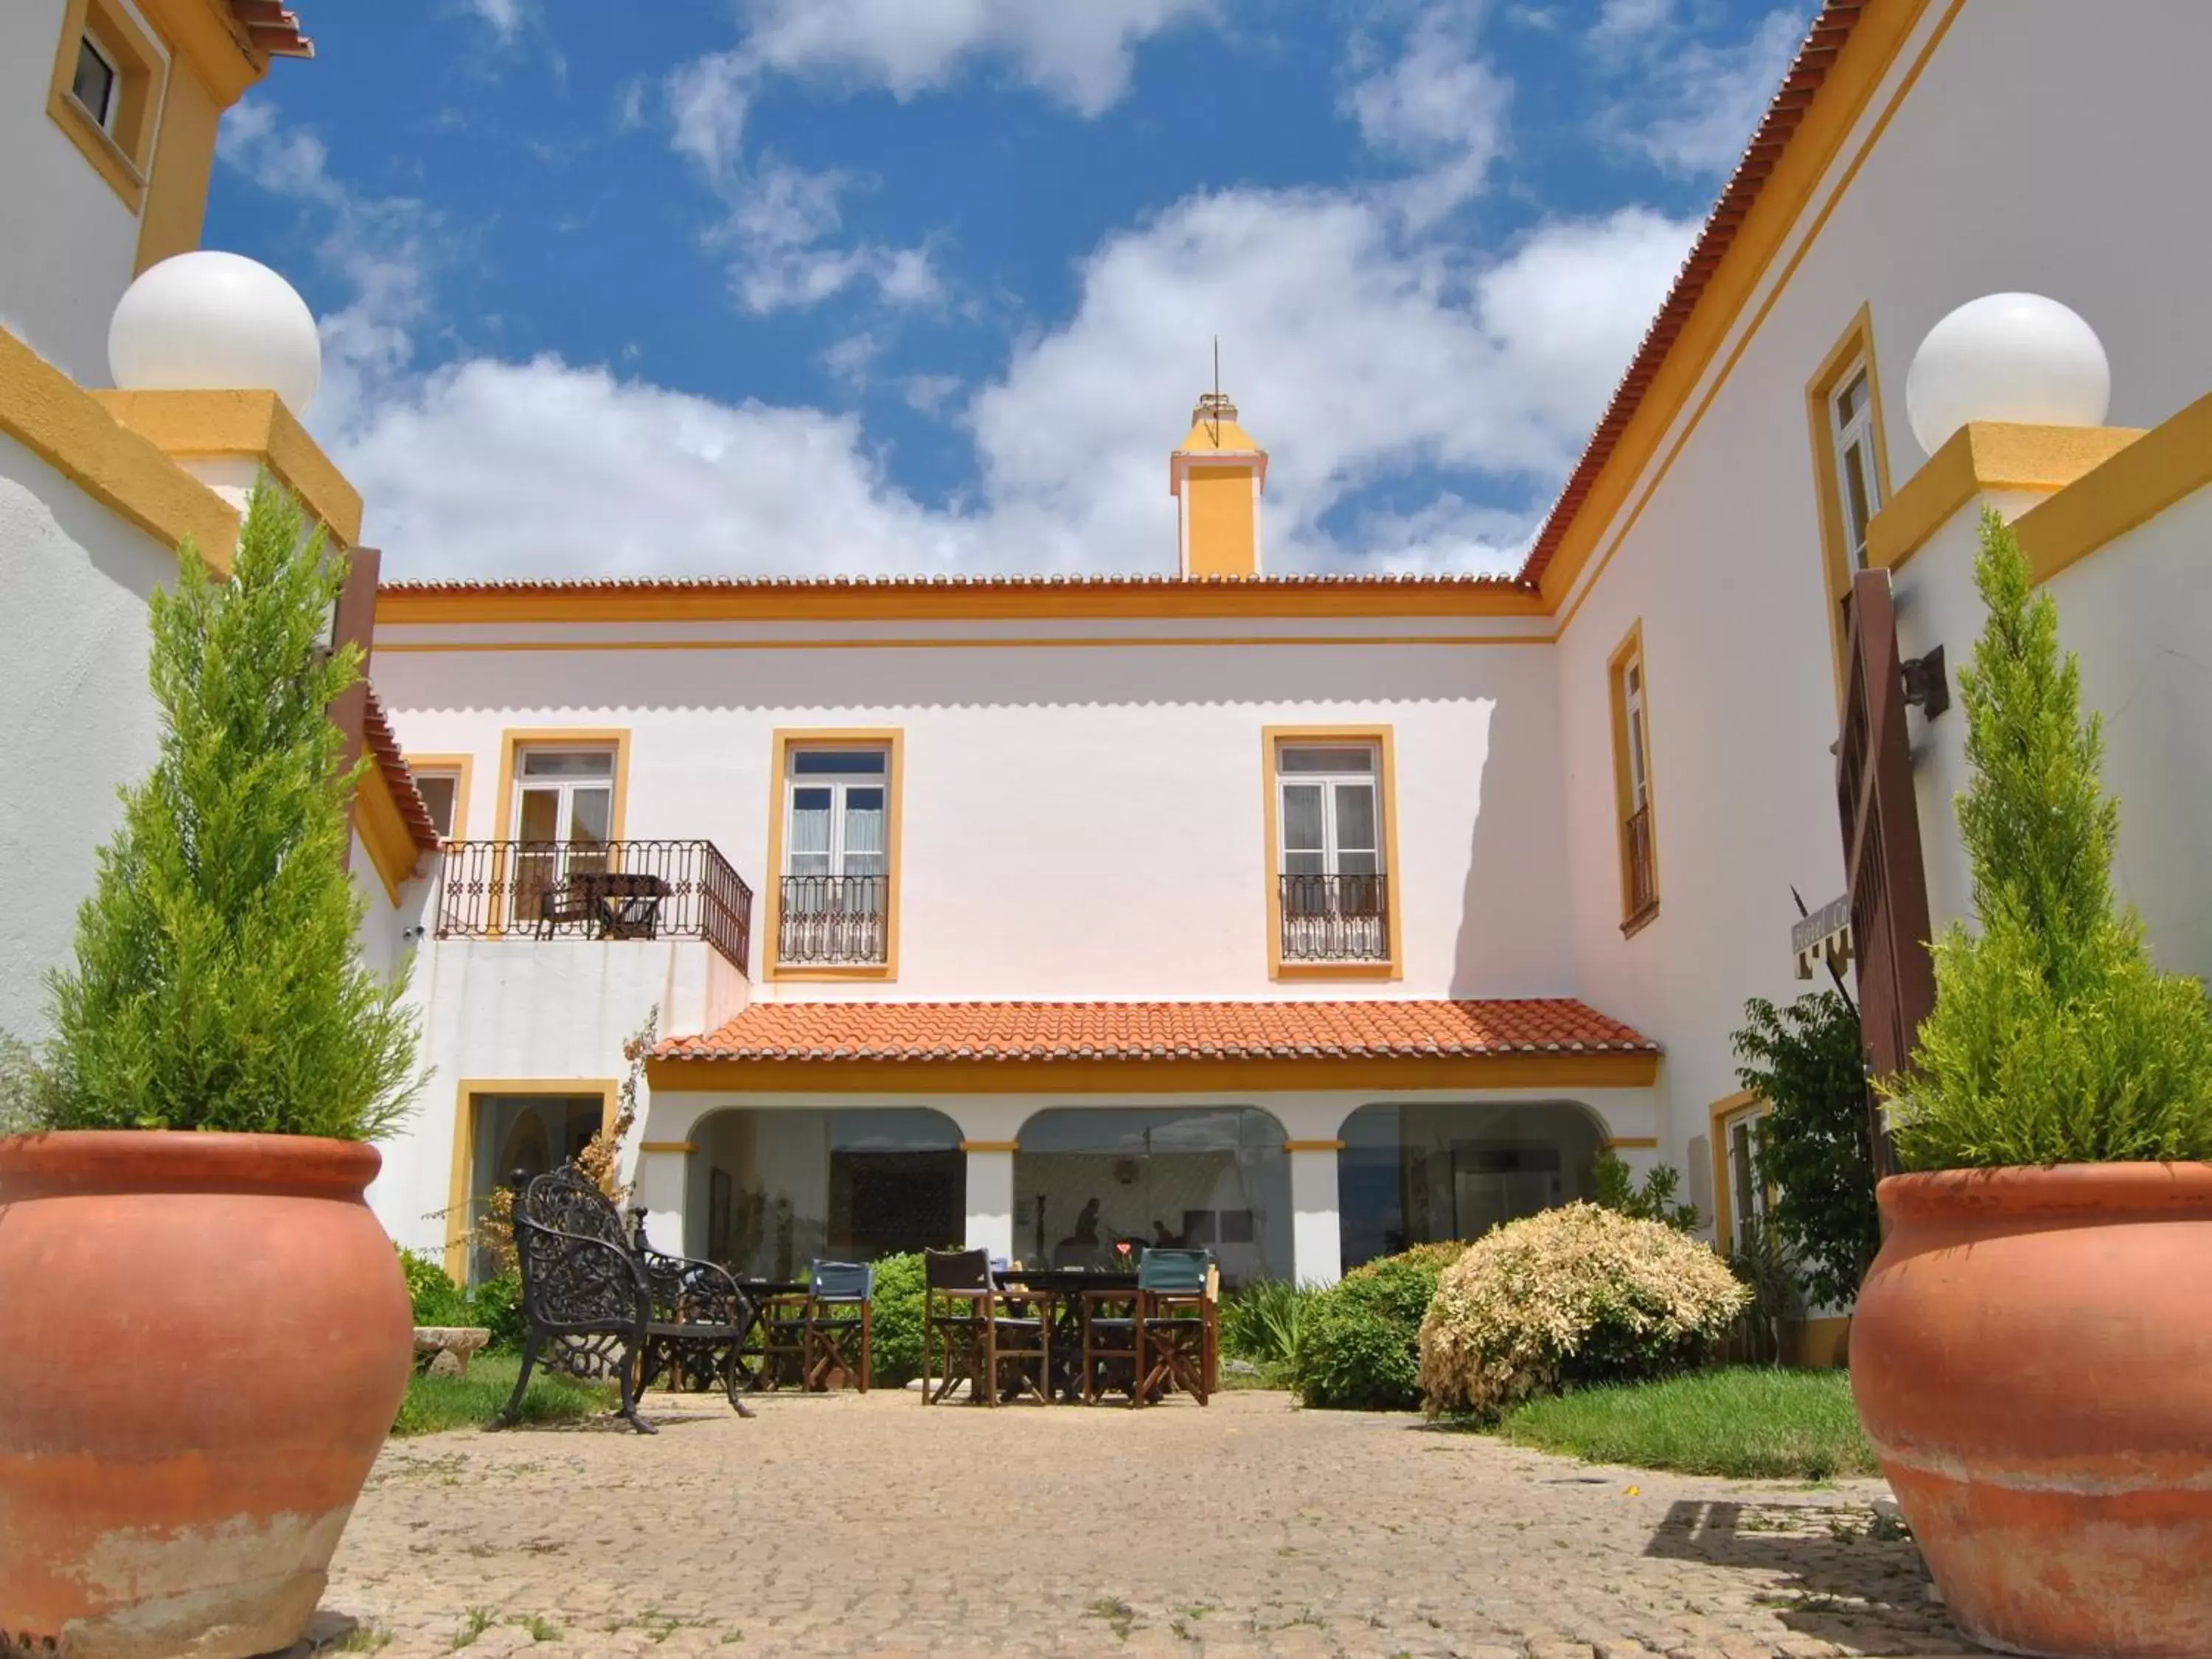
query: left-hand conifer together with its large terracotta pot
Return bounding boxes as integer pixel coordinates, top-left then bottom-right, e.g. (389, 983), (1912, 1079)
(0, 482), (418, 1659)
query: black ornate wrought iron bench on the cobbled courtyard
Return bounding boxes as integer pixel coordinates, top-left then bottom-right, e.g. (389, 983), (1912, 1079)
(498, 1164), (752, 1433)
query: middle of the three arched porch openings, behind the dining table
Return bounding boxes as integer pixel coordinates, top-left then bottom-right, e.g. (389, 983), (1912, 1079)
(1013, 1106), (1292, 1285)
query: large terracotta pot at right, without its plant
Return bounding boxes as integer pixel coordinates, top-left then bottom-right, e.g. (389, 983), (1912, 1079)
(1851, 1164), (2212, 1659)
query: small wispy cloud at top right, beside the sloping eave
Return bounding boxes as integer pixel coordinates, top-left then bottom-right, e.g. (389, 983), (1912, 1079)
(1588, 0), (1805, 177)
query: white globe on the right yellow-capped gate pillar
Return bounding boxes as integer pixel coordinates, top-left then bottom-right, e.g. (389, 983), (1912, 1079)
(1905, 294), (2112, 456)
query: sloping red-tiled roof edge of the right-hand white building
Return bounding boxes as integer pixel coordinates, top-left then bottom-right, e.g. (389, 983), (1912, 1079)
(1520, 0), (1869, 582)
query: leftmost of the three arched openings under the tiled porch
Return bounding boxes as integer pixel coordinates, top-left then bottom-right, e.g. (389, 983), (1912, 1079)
(684, 1106), (967, 1279)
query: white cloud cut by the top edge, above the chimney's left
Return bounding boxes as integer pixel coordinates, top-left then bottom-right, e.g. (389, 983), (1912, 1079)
(745, 0), (1214, 115)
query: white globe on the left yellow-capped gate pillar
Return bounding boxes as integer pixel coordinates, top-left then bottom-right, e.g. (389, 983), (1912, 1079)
(108, 250), (323, 418)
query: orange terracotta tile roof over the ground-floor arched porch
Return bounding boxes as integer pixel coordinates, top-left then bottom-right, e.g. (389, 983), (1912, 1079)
(655, 998), (1659, 1064)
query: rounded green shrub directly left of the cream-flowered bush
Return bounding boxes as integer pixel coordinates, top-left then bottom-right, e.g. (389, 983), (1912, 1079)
(1292, 1243), (1467, 1411)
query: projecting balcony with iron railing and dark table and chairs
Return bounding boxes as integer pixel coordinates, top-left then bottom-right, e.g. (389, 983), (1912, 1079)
(438, 841), (752, 973)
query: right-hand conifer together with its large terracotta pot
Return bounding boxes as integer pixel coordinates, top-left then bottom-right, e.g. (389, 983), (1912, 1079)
(1851, 513), (2212, 1657)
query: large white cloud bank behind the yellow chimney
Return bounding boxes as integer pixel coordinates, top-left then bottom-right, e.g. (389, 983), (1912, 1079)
(332, 190), (1690, 575)
